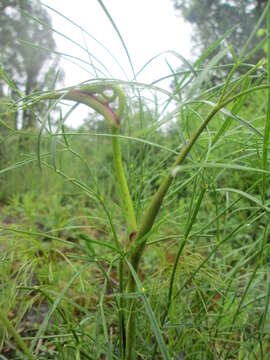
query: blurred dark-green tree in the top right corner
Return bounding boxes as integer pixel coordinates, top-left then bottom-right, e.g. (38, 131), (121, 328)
(173, 0), (267, 63)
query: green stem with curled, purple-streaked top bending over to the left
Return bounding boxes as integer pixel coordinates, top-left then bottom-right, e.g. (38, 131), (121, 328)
(39, 83), (137, 358)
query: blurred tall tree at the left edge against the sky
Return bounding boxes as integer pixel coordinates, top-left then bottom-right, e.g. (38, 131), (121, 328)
(0, 0), (61, 128)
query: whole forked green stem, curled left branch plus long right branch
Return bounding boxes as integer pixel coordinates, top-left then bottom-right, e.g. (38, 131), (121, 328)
(30, 81), (269, 360)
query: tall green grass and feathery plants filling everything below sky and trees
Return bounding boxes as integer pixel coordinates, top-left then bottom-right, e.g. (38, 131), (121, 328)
(0, 1), (270, 360)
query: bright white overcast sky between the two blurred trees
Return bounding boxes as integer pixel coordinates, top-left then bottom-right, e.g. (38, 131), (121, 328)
(42, 0), (191, 126)
